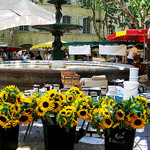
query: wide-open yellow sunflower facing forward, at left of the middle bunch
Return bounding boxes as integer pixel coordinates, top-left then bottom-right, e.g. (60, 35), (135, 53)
(39, 98), (54, 112)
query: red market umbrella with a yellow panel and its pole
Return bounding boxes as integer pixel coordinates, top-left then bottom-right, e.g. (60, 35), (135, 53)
(107, 29), (150, 61)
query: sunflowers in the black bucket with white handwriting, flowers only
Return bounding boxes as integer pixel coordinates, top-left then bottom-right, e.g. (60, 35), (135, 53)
(91, 96), (150, 133)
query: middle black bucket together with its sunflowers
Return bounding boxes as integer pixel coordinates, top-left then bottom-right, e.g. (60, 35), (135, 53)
(32, 87), (92, 150)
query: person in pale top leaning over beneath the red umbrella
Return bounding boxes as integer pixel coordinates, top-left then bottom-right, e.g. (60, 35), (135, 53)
(127, 45), (138, 64)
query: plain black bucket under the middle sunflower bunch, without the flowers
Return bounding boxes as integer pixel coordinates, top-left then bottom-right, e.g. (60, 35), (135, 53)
(43, 124), (76, 150)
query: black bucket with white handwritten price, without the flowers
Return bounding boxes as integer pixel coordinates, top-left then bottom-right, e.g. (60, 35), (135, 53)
(104, 128), (136, 150)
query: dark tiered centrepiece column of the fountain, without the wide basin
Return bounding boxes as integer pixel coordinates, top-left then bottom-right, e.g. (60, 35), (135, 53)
(33, 0), (82, 60)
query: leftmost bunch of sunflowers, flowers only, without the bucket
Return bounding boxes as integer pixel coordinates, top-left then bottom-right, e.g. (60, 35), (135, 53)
(0, 85), (34, 128)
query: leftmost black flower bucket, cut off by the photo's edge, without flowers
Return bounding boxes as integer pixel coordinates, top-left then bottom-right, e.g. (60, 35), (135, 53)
(0, 125), (19, 150)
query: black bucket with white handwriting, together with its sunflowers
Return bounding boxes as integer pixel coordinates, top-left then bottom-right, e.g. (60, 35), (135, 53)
(91, 96), (150, 150)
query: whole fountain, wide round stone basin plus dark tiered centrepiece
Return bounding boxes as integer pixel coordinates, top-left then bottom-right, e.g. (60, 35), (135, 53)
(0, 0), (133, 91)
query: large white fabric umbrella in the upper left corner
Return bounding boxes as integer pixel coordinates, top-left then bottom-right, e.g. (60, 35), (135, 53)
(0, 0), (56, 30)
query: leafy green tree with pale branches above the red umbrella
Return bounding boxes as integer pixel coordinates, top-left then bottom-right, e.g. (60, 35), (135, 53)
(80, 0), (150, 39)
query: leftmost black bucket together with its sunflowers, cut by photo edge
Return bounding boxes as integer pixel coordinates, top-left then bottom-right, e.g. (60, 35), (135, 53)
(0, 85), (33, 150)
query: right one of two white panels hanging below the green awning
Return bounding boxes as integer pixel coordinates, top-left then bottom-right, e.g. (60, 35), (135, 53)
(99, 45), (127, 56)
